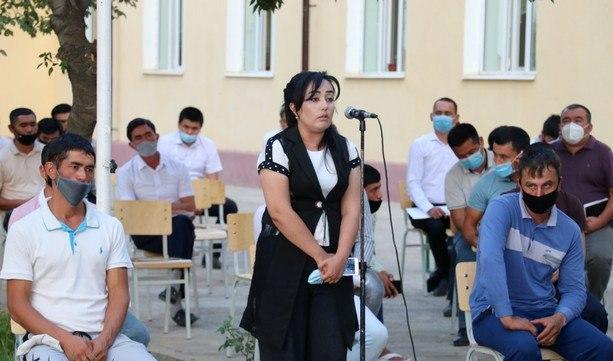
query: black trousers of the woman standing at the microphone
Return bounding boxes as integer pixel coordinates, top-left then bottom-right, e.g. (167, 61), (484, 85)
(259, 267), (353, 361)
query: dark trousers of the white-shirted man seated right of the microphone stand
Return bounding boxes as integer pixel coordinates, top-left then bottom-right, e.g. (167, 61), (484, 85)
(411, 217), (451, 278)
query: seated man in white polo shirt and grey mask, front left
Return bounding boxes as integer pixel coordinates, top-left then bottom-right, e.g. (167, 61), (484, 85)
(0, 135), (155, 361)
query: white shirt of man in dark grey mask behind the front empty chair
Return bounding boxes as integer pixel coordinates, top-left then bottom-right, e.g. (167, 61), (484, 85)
(117, 154), (194, 202)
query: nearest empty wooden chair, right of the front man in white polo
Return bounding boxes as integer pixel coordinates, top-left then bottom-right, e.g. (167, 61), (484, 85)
(115, 201), (192, 339)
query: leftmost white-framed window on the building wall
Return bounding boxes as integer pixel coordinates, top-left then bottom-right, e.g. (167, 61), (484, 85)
(143, 0), (183, 72)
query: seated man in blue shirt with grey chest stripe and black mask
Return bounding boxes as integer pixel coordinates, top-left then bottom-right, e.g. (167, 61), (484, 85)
(470, 143), (613, 361)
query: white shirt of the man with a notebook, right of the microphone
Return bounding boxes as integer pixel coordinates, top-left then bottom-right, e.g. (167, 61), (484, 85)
(407, 132), (458, 212)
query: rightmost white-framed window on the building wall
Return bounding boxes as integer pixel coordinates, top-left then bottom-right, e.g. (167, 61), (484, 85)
(464, 0), (536, 76)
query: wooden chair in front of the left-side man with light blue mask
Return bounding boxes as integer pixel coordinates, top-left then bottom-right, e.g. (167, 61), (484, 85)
(192, 178), (228, 298)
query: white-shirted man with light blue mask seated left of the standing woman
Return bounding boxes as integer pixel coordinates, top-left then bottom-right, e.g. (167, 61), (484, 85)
(159, 107), (238, 268)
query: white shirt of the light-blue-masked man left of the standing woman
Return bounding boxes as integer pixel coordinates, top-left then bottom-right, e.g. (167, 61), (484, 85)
(158, 131), (223, 179)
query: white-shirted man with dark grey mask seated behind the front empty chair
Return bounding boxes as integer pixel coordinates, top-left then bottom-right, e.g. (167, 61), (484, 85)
(117, 118), (198, 326)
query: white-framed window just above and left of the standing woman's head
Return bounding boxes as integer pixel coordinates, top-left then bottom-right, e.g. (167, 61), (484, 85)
(226, 0), (274, 76)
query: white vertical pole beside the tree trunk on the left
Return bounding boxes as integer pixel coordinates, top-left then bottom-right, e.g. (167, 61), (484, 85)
(96, 0), (113, 213)
